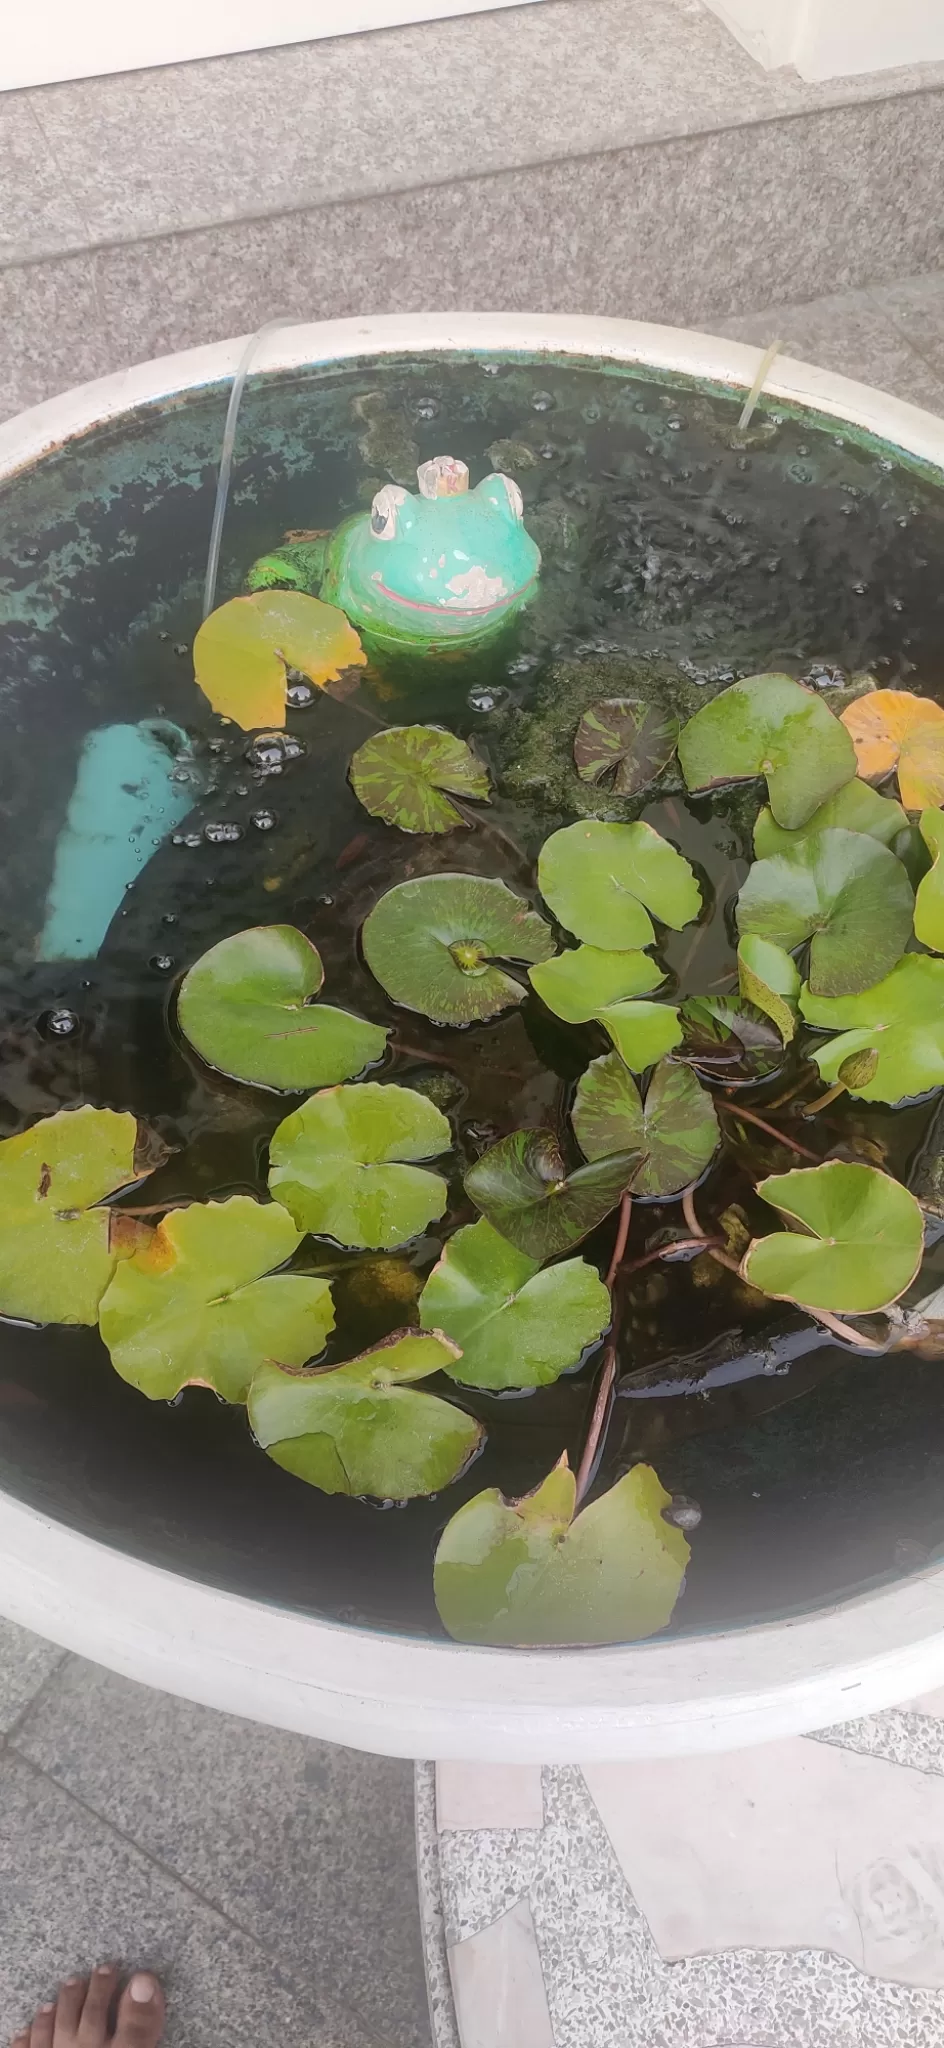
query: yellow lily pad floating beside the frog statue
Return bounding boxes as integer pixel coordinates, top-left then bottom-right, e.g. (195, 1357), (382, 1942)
(192, 590), (367, 733)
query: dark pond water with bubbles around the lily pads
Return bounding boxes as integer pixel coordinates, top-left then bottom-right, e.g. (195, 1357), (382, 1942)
(0, 344), (944, 1632)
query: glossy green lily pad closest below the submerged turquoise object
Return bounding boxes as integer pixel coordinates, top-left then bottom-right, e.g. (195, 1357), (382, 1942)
(176, 924), (387, 1090)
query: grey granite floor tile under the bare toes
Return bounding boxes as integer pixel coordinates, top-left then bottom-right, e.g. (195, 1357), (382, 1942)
(0, 1751), (374, 2048)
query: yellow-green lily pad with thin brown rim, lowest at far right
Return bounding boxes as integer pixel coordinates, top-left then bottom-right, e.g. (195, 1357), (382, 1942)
(741, 1159), (924, 1315)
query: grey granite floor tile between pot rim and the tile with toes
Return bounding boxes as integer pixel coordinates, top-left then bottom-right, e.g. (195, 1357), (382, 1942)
(14, 1659), (430, 2048)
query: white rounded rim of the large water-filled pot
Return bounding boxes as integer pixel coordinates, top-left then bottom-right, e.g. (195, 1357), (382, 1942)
(0, 313), (944, 1763)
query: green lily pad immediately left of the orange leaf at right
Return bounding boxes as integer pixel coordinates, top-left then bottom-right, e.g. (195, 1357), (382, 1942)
(678, 676), (856, 831)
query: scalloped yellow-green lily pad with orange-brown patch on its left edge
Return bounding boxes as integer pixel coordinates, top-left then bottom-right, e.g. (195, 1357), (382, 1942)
(98, 1194), (334, 1401)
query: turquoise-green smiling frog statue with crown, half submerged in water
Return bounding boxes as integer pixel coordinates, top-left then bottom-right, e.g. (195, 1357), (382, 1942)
(246, 455), (541, 653)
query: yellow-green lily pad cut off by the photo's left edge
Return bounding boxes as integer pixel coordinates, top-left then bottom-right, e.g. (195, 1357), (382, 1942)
(0, 1104), (141, 1323)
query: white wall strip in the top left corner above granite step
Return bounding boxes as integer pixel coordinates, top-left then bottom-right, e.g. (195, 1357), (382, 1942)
(0, 0), (540, 92)
